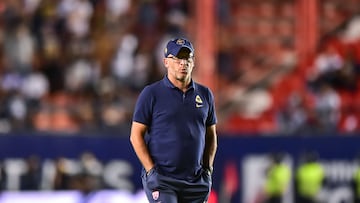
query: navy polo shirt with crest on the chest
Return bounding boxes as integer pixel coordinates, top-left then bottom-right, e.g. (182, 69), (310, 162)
(133, 76), (217, 180)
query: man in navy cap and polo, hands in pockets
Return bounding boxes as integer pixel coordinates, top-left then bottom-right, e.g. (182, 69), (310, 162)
(130, 38), (217, 203)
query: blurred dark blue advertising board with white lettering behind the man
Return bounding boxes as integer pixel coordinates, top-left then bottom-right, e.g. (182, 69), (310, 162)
(0, 134), (360, 203)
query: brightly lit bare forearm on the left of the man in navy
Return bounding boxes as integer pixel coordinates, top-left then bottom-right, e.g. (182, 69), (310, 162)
(130, 121), (155, 172)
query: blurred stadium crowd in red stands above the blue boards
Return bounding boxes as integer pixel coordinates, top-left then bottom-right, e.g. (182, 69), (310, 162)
(0, 0), (360, 135)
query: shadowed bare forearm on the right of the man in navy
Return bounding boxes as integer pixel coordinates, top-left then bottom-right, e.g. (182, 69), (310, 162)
(203, 124), (217, 172)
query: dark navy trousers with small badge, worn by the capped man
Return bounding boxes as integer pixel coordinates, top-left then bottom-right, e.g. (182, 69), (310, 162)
(141, 168), (212, 203)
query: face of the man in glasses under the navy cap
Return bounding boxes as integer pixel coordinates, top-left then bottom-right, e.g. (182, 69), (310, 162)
(164, 49), (195, 82)
